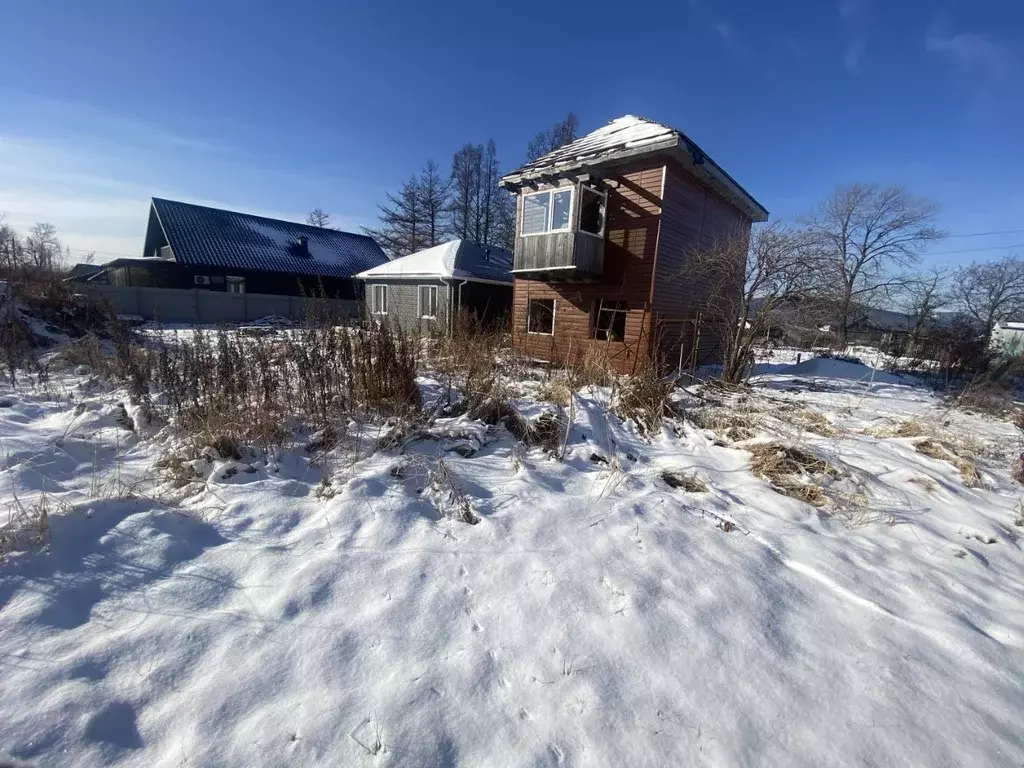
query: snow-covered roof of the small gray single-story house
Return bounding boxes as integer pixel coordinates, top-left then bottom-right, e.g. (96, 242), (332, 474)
(355, 240), (512, 285)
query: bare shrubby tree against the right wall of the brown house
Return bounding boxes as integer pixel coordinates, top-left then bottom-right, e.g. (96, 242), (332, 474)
(687, 221), (813, 383)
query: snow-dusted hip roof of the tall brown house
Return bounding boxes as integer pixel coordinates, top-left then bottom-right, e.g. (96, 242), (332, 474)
(501, 115), (768, 221)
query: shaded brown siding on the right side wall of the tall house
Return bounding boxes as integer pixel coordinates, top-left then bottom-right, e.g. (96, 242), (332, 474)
(652, 162), (751, 366)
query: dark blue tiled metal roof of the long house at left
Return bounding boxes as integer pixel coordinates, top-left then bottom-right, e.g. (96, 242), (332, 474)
(146, 198), (388, 278)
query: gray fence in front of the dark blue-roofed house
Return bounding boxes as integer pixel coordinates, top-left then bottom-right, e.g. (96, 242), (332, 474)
(81, 285), (362, 324)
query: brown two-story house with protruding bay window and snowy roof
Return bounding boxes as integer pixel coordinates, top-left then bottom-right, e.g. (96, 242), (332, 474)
(501, 115), (768, 373)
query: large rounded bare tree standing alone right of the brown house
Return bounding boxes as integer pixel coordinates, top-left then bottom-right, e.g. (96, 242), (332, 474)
(805, 184), (944, 346)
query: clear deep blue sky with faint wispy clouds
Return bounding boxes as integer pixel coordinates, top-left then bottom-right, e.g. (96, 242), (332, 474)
(0, 0), (1024, 263)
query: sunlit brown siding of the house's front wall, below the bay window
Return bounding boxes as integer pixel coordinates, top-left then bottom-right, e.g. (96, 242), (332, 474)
(512, 163), (665, 373)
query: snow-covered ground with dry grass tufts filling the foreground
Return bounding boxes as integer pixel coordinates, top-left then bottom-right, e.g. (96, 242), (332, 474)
(0, 360), (1024, 768)
